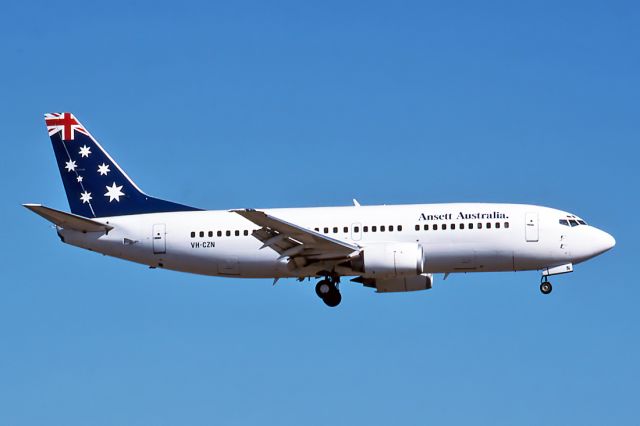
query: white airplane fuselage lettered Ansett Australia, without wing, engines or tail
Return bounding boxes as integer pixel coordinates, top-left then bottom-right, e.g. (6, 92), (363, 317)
(58, 203), (614, 278)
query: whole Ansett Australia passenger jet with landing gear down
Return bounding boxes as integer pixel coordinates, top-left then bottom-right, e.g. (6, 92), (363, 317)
(24, 112), (615, 307)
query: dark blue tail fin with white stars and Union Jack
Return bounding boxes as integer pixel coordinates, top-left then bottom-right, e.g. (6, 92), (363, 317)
(45, 112), (199, 217)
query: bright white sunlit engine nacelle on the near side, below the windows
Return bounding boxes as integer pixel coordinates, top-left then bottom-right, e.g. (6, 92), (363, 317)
(359, 243), (424, 278)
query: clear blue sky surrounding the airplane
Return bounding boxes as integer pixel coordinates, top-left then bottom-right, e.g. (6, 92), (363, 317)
(0, 1), (640, 425)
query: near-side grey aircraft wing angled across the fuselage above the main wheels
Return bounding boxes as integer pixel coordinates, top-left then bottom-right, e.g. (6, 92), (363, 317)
(231, 209), (360, 264)
